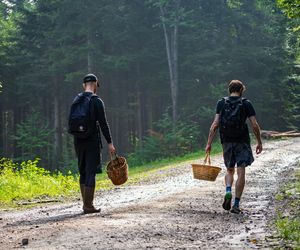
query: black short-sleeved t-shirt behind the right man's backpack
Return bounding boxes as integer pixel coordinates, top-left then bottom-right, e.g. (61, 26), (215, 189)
(216, 96), (256, 143)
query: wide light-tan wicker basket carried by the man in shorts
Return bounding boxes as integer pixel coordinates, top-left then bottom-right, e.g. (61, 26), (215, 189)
(192, 154), (222, 181)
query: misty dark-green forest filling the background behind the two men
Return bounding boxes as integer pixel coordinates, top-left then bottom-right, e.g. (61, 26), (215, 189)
(0, 0), (300, 170)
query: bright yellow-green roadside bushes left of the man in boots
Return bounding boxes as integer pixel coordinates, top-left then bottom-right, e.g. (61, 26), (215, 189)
(0, 158), (78, 204)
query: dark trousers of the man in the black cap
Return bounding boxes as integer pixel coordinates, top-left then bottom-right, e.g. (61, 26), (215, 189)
(74, 138), (101, 187)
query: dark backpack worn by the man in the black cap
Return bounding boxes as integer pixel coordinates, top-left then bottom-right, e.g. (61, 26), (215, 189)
(68, 93), (97, 139)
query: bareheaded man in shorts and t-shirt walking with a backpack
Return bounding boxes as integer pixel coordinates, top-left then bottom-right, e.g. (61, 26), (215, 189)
(205, 80), (262, 213)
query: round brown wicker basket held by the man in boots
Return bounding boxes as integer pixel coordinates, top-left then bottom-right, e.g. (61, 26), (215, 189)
(106, 155), (128, 186)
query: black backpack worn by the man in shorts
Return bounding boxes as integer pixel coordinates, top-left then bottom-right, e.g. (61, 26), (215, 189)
(220, 97), (247, 138)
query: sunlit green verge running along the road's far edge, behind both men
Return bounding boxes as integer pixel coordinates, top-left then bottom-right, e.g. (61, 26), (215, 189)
(0, 143), (221, 207)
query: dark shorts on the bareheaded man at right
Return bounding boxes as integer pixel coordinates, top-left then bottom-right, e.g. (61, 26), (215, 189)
(222, 142), (254, 168)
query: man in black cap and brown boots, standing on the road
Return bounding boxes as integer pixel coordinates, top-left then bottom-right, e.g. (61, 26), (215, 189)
(69, 74), (115, 214)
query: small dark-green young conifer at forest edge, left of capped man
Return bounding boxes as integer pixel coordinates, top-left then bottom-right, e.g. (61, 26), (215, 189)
(13, 111), (52, 160)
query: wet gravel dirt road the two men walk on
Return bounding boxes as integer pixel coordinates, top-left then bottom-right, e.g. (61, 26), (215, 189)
(0, 138), (300, 249)
